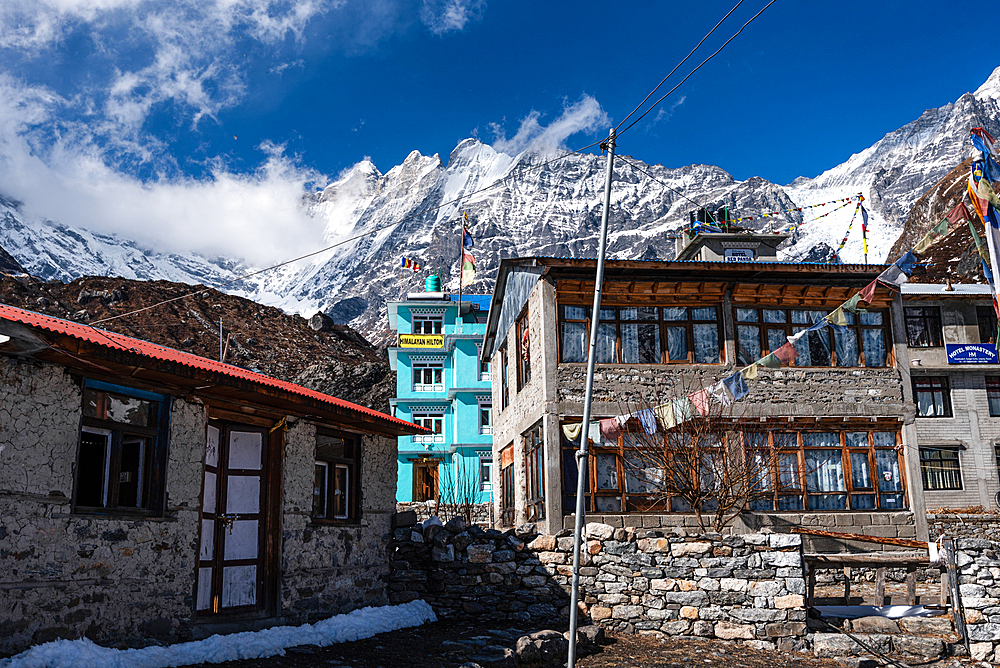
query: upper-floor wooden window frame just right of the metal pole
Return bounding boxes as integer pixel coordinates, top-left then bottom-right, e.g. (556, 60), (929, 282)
(556, 302), (726, 366)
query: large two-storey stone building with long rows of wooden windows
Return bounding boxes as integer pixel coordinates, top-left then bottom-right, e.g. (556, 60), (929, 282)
(483, 257), (927, 540)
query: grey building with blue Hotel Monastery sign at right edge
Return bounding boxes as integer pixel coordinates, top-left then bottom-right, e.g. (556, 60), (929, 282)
(899, 283), (1000, 512)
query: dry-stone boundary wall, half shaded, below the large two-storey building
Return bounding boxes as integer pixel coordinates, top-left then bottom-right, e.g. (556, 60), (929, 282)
(389, 513), (806, 649)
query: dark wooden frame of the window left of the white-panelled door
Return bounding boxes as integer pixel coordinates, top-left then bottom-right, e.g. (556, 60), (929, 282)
(73, 380), (171, 517)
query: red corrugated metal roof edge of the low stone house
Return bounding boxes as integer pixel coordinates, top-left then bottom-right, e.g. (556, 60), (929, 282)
(0, 304), (422, 431)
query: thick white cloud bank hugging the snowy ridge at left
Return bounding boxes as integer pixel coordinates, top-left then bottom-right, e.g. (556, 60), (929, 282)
(0, 76), (325, 264)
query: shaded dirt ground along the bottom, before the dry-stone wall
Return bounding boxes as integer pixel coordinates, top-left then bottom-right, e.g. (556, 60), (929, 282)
(180, 622), (843, 668)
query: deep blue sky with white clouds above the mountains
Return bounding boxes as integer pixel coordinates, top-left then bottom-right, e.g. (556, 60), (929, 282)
(0, 0), (1000, 261)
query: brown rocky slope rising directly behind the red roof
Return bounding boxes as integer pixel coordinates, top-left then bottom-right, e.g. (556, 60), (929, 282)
(0, 276), (395, 411)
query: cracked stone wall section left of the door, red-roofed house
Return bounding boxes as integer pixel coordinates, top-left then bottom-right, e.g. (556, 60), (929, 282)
(0, 358), (205, 653)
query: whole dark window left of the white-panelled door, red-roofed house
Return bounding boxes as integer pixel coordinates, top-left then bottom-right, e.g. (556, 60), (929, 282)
(74, 383), (168, 514)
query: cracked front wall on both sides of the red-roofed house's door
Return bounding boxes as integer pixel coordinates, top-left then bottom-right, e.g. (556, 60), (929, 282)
(0, 357), (406, 653)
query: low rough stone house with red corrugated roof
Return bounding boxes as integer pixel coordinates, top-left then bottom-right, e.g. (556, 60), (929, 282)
(0, 305), (421, 653)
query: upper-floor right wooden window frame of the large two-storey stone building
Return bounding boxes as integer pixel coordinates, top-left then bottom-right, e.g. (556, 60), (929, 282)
(733, 304), (895, 369)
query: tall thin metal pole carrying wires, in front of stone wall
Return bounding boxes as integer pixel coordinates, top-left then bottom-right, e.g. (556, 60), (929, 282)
(566, 128), (615, 668)
